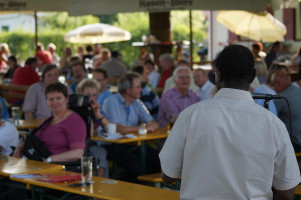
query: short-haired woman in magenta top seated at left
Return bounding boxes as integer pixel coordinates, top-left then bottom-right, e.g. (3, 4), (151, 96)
(15, 83), (86, 162)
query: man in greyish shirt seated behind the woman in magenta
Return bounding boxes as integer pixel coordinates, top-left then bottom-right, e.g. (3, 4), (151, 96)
(23, 65), (72, 119)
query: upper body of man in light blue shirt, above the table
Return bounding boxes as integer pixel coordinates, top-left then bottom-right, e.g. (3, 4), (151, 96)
(103, 72), (158, 133)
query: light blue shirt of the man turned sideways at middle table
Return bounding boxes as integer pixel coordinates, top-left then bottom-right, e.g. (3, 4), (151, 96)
(103, 93), (153, 126)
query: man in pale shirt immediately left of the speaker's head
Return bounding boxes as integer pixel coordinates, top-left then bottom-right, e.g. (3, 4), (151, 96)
(193, 68), (214, 100)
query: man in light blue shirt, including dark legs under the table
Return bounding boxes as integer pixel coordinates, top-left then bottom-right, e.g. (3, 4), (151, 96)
(103, 72), (160, 182)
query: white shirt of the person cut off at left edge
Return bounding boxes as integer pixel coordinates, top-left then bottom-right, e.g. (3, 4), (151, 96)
(0, 122), (19, 156)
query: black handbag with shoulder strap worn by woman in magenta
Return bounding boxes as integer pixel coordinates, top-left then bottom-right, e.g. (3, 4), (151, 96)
(23, 117), (52, 161)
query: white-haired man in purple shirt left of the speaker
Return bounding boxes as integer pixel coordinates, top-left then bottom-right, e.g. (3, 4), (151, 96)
(159, 66), (201, 127)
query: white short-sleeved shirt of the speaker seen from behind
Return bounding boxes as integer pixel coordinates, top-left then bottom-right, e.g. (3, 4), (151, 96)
(159, 88), (301, 200)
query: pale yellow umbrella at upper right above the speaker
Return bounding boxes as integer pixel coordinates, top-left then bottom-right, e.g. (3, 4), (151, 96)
(216, 11), (286, 42)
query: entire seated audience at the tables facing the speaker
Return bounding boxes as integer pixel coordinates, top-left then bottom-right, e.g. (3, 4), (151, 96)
(0, 41), (301, 198)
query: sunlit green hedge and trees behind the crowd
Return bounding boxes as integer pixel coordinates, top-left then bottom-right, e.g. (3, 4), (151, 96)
(0, 11), (208, 67)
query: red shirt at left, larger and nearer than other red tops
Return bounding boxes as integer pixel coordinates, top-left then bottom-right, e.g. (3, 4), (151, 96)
(12, 67), (40, 85)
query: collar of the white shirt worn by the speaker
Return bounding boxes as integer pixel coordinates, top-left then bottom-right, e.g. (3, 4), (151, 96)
(214, 88), (254, 102)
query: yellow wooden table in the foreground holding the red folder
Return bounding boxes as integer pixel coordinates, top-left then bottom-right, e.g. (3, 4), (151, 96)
(11, 171), (180, 200)
